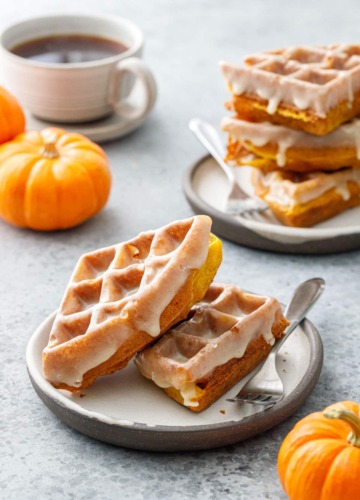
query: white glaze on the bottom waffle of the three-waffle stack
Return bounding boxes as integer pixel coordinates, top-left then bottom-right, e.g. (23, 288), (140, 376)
(254, 168), (360, 207)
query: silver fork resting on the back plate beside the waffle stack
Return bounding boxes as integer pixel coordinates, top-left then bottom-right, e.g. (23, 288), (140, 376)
(189, 118), (269, 215)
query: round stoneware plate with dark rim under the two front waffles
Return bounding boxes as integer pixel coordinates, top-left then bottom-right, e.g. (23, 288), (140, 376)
(26, 313), (323, 451)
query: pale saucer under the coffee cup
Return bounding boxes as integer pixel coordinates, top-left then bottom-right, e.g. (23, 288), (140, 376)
(26, 80), (151, 143)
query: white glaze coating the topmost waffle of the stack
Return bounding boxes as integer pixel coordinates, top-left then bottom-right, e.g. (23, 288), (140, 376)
(220, 44), (360, 117)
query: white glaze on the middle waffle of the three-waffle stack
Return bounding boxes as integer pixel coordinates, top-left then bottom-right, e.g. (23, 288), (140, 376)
(221, 117), (360, 167)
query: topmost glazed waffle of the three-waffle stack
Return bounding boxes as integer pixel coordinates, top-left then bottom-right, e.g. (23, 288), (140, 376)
(221, 44), (360, 135)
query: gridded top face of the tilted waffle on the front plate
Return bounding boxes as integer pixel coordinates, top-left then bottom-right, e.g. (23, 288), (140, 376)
(49, 220), (195, 347)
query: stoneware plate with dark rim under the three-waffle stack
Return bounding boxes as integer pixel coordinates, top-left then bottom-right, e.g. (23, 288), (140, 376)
(183, 156), (360, 254)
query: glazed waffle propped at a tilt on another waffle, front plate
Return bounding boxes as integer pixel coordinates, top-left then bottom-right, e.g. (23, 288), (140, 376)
(43, 215), (222, 391)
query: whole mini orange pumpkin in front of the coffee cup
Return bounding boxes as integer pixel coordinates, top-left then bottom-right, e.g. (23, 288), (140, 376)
(0, 128), (111, 231)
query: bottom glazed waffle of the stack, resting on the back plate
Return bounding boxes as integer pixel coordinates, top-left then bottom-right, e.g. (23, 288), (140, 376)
(252, 168), (360, 227)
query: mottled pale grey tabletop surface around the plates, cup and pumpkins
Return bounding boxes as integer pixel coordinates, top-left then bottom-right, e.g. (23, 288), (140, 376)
(0, 0), (360, 500)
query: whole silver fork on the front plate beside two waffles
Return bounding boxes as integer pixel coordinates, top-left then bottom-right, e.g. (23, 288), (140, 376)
(227, 278), (325, 409)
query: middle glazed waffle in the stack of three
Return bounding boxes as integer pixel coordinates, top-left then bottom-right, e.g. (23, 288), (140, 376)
(221, 117), (360, 172)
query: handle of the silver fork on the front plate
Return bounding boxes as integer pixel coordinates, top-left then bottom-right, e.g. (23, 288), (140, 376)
(273, 278), (325, 354)
